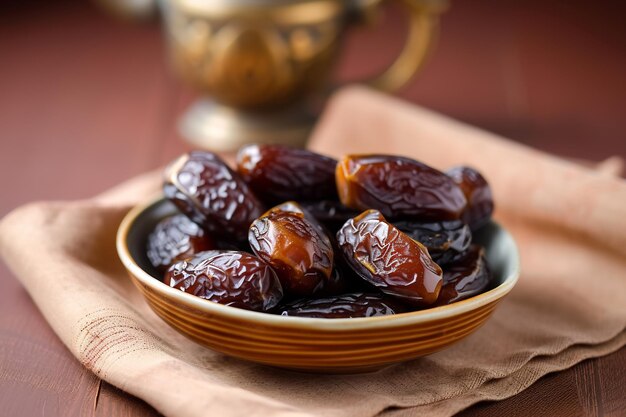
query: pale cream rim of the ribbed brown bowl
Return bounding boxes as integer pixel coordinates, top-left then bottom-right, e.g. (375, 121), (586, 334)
(116, 196), (520, 331)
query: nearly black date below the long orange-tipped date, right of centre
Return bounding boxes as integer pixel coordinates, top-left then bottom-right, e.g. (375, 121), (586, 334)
(393, 220), (472, 265)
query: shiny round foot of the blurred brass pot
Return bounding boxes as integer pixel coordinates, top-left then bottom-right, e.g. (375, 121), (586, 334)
(179, 99), (315, 152)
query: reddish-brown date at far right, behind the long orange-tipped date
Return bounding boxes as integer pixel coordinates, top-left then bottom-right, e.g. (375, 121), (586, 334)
(446, 166), (493, 230)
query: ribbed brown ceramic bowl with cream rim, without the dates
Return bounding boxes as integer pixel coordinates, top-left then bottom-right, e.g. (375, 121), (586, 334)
(117, 199), (519, 373)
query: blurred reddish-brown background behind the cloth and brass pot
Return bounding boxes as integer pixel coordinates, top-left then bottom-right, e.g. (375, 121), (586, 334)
(0, 0), (626, 216)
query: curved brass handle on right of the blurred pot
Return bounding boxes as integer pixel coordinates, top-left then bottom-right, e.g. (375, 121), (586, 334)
(358, 0), (448, 92)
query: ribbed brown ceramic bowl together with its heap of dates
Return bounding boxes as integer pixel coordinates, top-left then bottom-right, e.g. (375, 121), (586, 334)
(117, 145), (519, 373)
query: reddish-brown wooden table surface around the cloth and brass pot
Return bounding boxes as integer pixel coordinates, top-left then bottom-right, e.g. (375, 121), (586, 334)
(0, 0), (626, 417)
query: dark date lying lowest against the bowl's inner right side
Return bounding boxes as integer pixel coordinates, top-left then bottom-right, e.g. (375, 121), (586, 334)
(436, 245), (491, 306)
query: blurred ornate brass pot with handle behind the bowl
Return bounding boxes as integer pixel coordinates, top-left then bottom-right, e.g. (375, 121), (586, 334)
(160, 0), (446, 150)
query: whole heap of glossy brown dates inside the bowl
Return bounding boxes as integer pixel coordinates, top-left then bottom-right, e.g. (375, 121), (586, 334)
(147, 145), (493, 318)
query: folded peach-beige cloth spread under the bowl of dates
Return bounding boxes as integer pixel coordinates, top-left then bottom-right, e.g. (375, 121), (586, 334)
(0, 88), (626, 417)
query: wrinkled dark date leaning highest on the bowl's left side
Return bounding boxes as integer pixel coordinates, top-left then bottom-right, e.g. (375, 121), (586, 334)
(163, 151), (263, 241)
